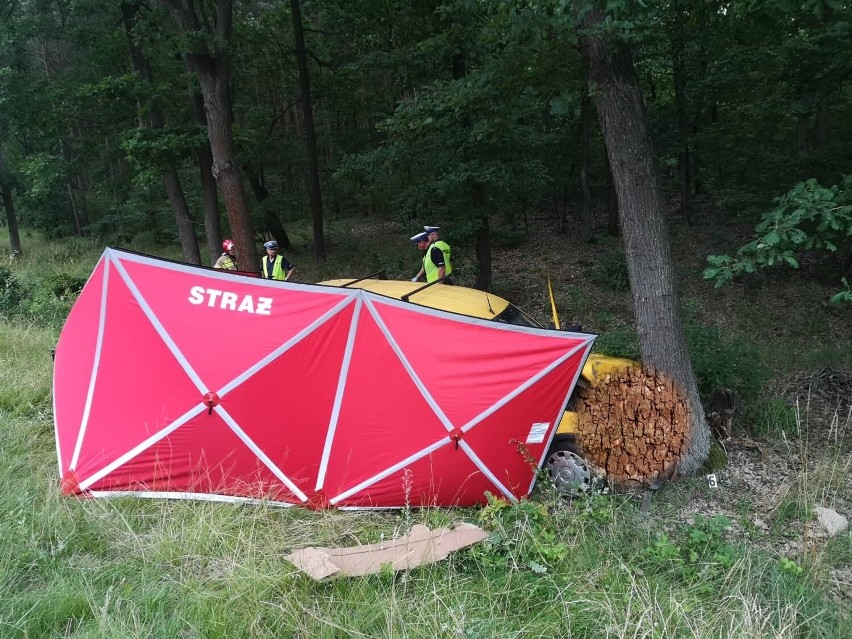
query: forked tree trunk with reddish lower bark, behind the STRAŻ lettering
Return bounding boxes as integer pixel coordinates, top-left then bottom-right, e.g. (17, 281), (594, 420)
(164, 0), (258, 271)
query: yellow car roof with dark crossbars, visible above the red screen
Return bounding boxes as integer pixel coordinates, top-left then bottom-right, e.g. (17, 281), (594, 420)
(317, 279), (511, 320)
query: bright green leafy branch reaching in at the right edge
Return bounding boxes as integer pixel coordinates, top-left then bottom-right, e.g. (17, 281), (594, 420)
(704, 175), (852, 302)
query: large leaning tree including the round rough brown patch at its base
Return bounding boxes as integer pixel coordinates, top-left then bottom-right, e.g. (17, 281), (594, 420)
(573, 0), (710, 482)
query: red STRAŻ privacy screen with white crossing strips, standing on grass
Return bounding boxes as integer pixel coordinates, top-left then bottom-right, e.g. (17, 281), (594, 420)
(53, 249), (594, 508)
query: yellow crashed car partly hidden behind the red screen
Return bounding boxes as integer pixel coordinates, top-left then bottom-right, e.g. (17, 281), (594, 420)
(318, 279), (636, 493)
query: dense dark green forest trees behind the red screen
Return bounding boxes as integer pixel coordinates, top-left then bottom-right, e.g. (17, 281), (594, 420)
(0, 0), (852, 282)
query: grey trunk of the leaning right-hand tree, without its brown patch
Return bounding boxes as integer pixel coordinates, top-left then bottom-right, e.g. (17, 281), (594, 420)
(574, 2), (710, 474)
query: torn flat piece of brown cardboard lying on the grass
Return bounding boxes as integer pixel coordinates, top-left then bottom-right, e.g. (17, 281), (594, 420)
(284, 523), (488, 579)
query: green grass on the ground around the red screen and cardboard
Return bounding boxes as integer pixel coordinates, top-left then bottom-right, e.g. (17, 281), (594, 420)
(0, 225), (852, 639)
